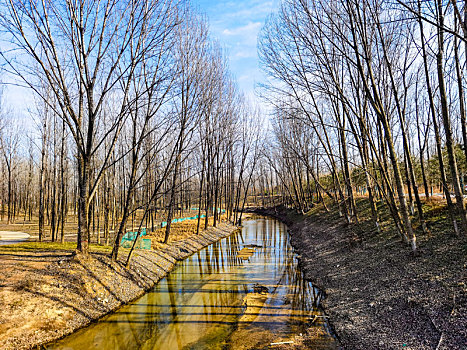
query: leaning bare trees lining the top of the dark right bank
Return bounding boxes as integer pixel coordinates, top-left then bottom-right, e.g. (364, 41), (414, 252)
(259, 0), (467, 251)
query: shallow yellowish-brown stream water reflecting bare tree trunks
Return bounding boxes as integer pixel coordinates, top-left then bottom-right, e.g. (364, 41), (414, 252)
(48, 217), (334, 350)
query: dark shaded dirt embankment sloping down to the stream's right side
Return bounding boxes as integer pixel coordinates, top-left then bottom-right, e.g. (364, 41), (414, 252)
(250, 208), (467, 350)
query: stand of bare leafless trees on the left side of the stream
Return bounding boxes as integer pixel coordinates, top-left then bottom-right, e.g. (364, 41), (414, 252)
(0, 1), (260, 260)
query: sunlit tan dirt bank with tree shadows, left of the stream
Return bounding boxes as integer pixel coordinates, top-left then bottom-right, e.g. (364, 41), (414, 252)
(0, 224), (236, 350)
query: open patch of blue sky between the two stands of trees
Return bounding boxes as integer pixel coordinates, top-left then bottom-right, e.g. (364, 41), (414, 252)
(192, 0), (279, 103)
